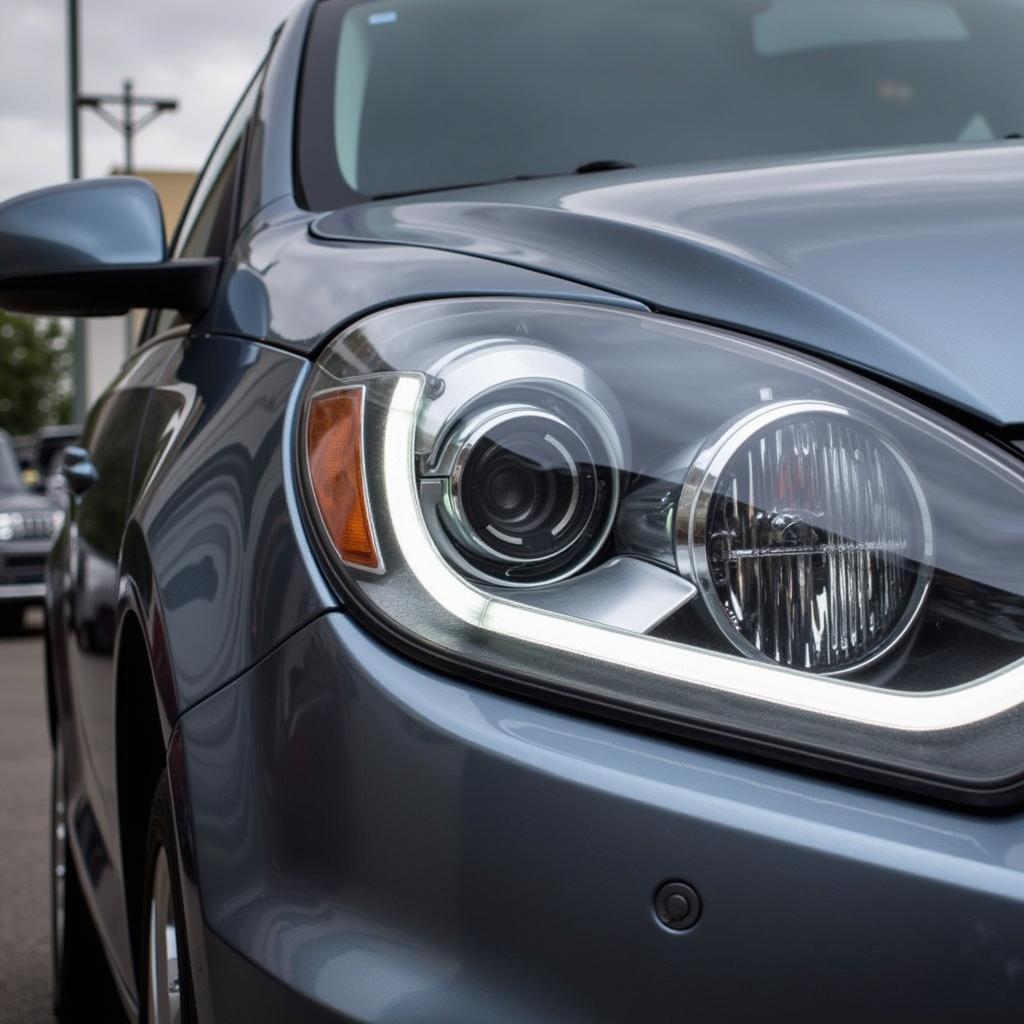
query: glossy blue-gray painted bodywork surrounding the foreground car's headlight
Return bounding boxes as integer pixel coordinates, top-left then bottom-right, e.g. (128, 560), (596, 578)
(36, 0), (1024, 1022)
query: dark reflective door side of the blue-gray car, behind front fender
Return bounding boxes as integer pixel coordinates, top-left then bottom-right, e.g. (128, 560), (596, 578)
(47, 337), (181, 997)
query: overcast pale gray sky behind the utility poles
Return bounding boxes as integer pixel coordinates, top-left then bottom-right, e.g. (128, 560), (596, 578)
(0, 0), (294, 201)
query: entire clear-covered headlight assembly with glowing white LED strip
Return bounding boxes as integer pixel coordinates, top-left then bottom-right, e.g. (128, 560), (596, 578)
(299, 299), (1024, 803)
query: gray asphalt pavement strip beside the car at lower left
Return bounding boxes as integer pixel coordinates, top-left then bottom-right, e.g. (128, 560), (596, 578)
(0, 612), (54, 1024)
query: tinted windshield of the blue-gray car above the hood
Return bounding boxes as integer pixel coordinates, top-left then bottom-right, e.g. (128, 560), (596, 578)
(301, 0), (1024, 208)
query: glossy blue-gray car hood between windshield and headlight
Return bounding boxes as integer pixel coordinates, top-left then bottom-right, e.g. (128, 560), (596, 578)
(312, 143), (1024, 426)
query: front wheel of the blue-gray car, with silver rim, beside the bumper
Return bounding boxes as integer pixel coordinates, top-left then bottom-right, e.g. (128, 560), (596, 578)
(138, 771), (196, 1024)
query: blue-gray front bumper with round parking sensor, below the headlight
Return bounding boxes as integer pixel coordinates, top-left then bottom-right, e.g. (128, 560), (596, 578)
(178, 613), (1024, 1024)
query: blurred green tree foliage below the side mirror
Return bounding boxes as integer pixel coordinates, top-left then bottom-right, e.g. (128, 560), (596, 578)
(0, 310), (72, 434)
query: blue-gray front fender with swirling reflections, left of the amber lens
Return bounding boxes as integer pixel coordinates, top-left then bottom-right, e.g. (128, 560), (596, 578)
(122, 338), (335, 723)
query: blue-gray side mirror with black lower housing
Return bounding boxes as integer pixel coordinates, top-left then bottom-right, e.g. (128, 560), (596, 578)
(0, 177), (220, 316)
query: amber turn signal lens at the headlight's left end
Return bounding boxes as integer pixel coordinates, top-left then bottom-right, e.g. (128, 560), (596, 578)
(306, 387), (381, 569)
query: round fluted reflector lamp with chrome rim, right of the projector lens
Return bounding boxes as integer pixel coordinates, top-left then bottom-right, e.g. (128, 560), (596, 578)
(684, 403), (932, 673)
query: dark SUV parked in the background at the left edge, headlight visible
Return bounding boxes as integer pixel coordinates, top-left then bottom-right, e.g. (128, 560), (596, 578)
(0, 430), (63, 634)
